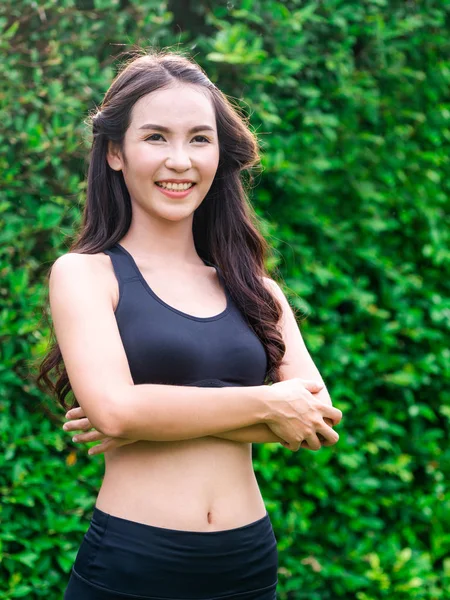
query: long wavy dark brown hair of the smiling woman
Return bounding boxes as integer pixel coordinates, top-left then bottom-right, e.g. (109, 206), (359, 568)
(36, 50), (285, 410)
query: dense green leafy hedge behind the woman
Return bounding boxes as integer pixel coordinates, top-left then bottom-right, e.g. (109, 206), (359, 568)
(0, 0), (450, 600)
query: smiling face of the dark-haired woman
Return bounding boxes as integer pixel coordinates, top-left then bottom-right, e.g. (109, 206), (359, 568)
(107, 84), (219, 221)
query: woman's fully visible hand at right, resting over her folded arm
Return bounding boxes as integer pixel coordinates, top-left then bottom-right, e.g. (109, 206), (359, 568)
(266, 377), (342, 452)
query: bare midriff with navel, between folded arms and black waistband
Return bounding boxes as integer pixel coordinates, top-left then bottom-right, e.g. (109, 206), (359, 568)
(96, 437), (266, 531)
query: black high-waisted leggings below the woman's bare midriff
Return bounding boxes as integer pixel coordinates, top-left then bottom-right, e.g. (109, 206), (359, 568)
(64, 506), (278, 600)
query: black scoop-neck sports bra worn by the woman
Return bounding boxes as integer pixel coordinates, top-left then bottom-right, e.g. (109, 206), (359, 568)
(104, 243), (267, 387)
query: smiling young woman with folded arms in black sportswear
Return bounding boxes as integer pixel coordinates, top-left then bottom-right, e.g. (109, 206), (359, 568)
(39, 51), (342, 600)
